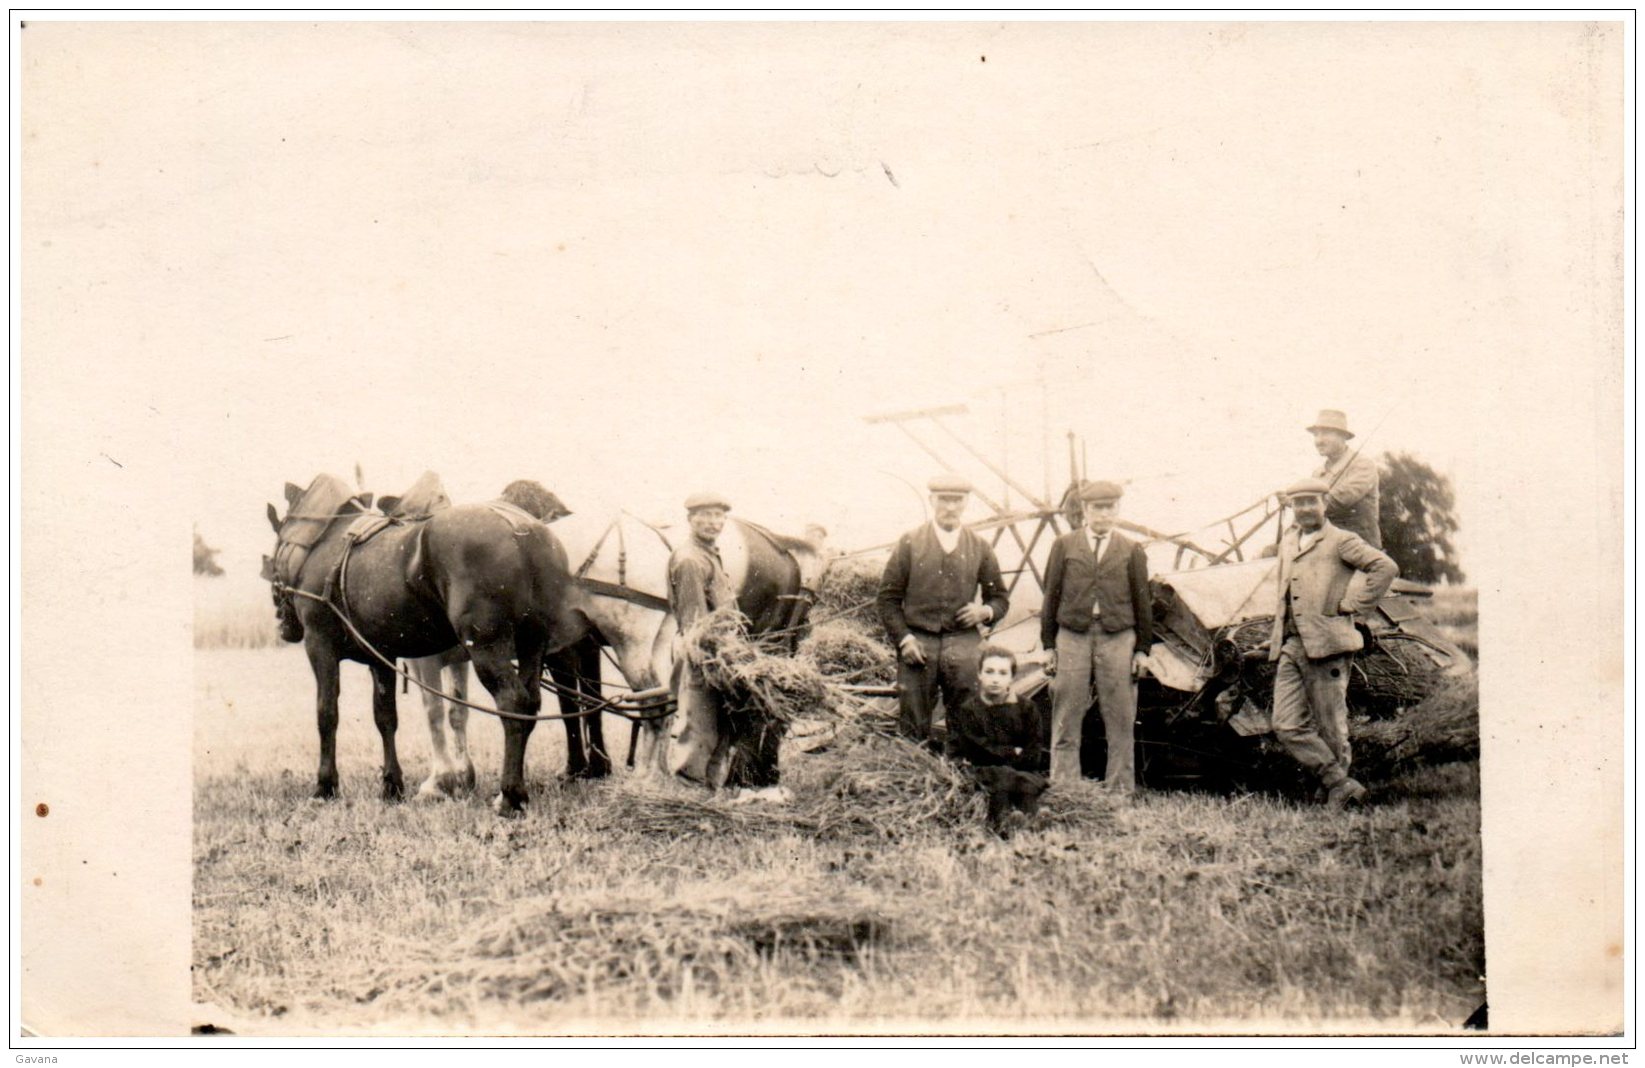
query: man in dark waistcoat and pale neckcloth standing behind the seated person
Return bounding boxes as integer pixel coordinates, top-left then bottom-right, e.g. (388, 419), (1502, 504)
(875, 476), (1010, 745)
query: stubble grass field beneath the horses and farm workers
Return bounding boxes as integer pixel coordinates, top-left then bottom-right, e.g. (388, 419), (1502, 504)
(194, 585), (1484, 1033)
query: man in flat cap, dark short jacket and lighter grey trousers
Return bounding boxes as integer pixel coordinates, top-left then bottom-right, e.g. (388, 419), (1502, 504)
(1040, 482), (1153, 793)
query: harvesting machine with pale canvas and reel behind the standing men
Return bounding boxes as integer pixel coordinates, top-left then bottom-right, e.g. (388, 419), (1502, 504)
(842, 406), (1477, 785)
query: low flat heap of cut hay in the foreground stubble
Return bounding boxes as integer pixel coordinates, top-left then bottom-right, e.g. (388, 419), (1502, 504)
(367, 880), (893, 1004)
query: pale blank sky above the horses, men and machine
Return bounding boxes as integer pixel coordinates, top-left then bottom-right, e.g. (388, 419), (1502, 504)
(23, 23), (1620, 582)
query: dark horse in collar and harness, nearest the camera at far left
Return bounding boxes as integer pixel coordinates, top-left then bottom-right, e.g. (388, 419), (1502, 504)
(263, 476), (582, 813)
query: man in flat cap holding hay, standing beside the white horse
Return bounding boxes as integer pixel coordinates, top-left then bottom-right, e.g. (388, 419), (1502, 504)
(668, 492), (737, 788)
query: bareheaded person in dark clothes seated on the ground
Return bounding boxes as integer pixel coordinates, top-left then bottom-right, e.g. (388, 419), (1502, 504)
(948, 645), (1046, 836)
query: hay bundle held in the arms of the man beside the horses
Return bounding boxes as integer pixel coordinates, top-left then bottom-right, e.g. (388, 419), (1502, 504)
(686, 607), (834, 726)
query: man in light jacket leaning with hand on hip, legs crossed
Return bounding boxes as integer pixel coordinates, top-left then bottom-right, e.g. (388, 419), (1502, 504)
(1268, 479), (1400, 808)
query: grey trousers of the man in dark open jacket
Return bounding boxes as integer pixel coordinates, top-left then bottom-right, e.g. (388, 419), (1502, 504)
(1051, 624), (1137, 792)
